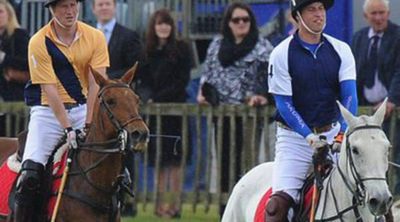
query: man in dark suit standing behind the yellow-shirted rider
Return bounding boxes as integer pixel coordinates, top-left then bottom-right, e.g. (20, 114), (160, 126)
(92, 0), (142, 79)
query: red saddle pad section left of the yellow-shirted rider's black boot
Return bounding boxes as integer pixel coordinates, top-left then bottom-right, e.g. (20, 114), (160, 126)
(0, 161), (18, 216)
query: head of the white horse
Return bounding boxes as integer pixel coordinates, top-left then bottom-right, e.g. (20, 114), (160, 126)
(338, 100), (393, 216)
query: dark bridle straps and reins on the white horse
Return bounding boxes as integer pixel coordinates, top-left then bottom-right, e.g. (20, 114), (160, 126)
(315, 125), (386, 222)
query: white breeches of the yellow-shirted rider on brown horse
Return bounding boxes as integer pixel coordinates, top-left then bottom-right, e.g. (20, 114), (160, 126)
(22, 105), (86, 165)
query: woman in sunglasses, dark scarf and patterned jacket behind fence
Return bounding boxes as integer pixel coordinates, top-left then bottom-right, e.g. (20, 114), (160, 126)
(197, 3), (272, 216)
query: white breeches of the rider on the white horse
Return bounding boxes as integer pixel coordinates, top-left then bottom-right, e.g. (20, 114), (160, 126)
(272, 124), (340, 202)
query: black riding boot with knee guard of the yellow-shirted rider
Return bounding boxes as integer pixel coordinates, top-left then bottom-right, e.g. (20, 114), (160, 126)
(14, 160), (44, 222)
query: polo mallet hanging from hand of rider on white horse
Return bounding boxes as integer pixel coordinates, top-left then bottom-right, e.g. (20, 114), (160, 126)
(310, 136), (329, 222)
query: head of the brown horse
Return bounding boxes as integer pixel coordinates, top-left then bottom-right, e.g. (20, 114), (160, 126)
(92, 64), (149, 151)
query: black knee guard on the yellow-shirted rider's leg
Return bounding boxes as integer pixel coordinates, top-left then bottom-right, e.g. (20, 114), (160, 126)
(16, 160), (44, 205)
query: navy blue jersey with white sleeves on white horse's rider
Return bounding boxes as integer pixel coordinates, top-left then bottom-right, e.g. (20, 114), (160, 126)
(268, 33), (356, 128)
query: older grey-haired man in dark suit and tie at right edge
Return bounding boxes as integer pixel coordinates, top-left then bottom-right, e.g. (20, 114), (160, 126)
(352, 0), (400, 194)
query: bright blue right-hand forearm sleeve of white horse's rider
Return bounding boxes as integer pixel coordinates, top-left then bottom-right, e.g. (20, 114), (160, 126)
(339, 80), (358, 132)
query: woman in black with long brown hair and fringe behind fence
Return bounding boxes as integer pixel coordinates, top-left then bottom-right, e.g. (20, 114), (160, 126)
(138, 9), (192, 218)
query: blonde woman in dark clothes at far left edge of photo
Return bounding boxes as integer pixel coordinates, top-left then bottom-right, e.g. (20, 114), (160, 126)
(0, 0), (29, 101)
